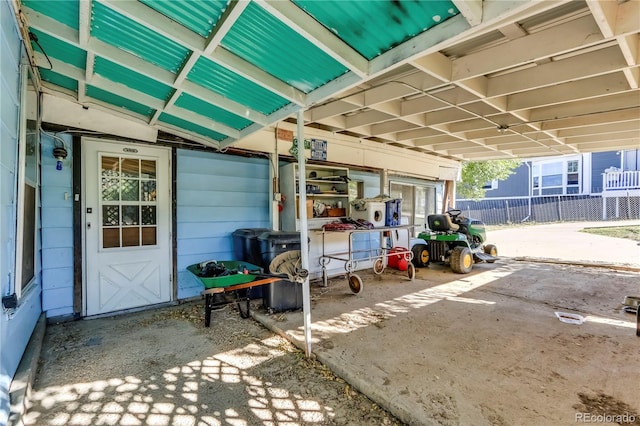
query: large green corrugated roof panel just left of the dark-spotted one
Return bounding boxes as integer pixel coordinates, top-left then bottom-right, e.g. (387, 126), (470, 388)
(222, 3), (347, 93)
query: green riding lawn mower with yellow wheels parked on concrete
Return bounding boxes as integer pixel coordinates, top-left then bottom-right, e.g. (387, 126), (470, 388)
(411, 209), (498, 274)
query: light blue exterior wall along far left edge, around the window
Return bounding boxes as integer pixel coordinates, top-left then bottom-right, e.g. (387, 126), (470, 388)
(0, 1), (41, 424)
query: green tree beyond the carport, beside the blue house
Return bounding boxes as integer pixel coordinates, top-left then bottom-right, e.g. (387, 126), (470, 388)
(456, 159), (520, 200)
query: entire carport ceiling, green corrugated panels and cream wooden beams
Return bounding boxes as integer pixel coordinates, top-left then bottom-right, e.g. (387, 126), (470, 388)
(20, 0), (640, 160)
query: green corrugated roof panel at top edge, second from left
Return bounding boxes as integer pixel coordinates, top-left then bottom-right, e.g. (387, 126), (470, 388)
(140, 0), (229, 37)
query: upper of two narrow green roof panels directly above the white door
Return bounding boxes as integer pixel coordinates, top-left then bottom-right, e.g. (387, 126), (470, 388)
(93, 57), (174, 101)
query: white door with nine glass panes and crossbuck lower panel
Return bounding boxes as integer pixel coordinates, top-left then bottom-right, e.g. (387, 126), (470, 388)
(82, 138), (173, 316)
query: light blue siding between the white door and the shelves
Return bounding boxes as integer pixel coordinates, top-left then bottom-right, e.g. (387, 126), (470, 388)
(176, 150), (270, 299)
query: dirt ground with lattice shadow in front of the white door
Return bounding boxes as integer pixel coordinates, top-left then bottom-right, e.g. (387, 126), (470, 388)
(26, 303), (404, 426)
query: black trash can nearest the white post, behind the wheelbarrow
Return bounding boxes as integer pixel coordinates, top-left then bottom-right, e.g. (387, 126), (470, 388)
(258, 231), (302, 312)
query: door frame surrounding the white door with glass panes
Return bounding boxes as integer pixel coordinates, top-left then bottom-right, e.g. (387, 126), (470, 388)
(79, 136), (177, 318)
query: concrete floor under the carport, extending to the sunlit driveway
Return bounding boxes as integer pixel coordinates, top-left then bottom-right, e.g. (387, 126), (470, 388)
(251, 222), (640, 425)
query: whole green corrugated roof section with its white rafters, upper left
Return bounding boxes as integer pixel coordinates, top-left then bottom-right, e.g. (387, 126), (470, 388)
(24, 0), (476, 150)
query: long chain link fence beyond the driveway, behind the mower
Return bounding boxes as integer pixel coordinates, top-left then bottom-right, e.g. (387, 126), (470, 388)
(456, 195), (640, 225)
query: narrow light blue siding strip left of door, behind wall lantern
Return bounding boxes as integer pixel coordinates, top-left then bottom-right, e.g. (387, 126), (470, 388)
(41, 134), (73, 318)
